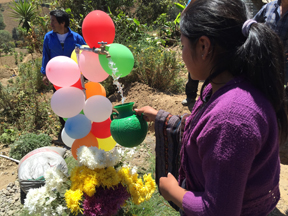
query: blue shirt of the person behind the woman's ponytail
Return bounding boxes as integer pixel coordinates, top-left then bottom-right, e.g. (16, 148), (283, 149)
(253, 0), (288, 53)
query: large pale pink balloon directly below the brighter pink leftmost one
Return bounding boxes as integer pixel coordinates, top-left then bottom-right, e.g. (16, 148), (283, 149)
(51, 87), (85, 118)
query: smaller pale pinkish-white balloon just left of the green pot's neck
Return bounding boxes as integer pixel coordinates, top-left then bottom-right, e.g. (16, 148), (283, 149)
(83, 95), (112, 122)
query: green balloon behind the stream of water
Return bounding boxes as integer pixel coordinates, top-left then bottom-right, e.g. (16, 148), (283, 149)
(99, 43), (134, 77)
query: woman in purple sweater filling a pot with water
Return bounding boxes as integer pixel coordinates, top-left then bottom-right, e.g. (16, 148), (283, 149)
(135, 0), (287, 216)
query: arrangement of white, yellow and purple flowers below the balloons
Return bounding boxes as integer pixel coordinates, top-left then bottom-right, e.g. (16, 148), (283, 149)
(24, 146), (156, 216)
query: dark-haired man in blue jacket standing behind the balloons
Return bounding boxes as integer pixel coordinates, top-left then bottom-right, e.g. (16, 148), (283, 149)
(41, 10), (86, 85)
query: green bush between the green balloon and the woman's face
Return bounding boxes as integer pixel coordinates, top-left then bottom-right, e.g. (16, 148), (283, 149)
(132, 46), (184, 93)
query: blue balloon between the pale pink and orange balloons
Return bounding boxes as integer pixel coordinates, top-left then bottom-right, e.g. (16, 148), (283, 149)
(65, 114), (91, 139)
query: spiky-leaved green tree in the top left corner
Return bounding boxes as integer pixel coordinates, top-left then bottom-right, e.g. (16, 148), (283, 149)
(10, 0), (36, 32)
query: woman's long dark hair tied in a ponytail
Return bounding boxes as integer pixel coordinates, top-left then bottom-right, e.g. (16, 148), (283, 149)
(180, 0), (288, 144)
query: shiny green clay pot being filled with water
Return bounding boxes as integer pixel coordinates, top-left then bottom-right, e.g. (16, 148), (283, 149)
(110, 102), (148, 148)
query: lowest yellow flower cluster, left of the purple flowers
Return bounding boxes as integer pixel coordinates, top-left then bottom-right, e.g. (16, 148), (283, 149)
(65, 190), (83, 215)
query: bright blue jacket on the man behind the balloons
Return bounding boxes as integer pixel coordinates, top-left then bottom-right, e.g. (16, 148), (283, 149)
(41, 27), (86, 75)
